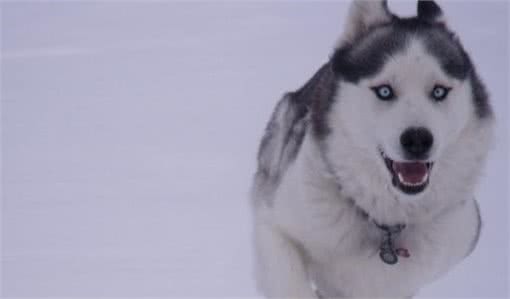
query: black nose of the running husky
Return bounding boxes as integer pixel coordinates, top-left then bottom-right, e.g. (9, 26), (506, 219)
(400, 128), (434, 159)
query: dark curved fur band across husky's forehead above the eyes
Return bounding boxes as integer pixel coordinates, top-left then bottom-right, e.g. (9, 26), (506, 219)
(331, 18), (472, 83)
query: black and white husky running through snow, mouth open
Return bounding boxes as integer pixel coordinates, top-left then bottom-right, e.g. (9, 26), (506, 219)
(252, 0), (493, 298)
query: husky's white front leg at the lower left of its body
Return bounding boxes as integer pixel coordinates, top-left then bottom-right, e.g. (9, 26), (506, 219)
(255, 223), (317, 298)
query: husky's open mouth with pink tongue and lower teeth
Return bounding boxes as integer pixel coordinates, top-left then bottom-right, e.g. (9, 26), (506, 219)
(380, 151), (434, 194)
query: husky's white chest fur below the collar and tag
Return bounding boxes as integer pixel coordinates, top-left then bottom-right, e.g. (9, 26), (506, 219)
(262, 144), (479, 297)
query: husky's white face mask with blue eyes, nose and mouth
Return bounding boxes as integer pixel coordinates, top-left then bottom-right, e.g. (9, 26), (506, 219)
(332, 38), (474, 194)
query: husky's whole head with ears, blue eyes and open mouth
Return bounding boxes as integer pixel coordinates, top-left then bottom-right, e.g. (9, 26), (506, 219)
(314, 0), (492, 203)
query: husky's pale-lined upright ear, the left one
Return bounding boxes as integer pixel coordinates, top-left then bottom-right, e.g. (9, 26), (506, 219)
(340, 0), (393, 44)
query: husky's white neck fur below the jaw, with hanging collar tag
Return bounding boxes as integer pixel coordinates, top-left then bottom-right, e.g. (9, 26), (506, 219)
(294, 135), (478, 265)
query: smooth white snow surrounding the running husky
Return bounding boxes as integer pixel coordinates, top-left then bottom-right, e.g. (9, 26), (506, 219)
(1, 1), (509, 297)
